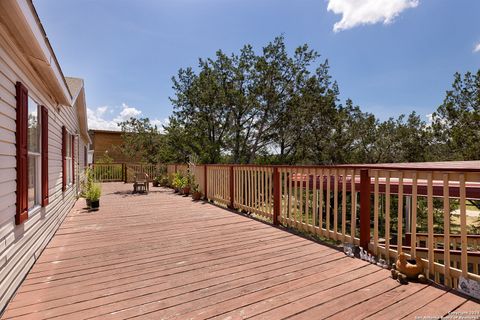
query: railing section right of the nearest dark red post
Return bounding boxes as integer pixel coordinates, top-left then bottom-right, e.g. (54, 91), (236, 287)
(368, 168), (480, 287)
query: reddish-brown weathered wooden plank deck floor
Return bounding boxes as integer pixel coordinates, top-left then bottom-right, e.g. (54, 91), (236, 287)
(2, 183), (480, 319)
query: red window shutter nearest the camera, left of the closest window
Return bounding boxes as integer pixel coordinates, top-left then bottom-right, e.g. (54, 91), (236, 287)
(15, 82), (28, 225)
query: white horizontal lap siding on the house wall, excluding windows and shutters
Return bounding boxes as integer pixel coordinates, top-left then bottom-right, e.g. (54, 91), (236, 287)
(0, 25), (85, 311)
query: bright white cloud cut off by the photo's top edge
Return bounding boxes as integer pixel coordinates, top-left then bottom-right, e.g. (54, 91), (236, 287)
(327, 0), (419, 32)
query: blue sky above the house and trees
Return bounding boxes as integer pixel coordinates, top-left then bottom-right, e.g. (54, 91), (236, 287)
(34, 0), (480, 129)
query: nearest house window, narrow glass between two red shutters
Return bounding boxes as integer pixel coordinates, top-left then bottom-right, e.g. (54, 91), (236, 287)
(27, 97), (41, 210)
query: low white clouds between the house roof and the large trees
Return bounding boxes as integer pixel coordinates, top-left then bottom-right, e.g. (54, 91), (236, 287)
(87, 103), (168, 131)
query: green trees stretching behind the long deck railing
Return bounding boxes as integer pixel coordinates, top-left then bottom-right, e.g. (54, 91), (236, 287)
(119, 37), (480, 164)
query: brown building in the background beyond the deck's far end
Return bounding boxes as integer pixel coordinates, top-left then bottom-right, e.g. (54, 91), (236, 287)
(89, 130), (139, 163)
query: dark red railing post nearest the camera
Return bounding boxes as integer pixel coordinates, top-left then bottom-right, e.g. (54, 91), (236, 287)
(360, 169), (371, 250)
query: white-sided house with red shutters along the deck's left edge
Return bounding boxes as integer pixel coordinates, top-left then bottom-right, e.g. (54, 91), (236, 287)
(0, 0), (89, 310)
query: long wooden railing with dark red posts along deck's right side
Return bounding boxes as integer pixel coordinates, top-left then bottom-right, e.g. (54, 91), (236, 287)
(167, 164), (480, 287)
